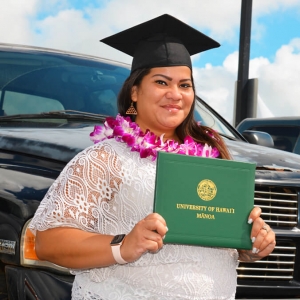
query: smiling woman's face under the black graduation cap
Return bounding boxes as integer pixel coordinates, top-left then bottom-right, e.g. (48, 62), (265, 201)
(131, 66), (194, 139)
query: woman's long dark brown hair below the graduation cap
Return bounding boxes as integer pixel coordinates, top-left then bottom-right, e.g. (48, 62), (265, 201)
(118, 68), (231, 159)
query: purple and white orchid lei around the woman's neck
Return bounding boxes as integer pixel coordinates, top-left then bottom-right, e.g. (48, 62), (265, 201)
(90, 114), (220, 160)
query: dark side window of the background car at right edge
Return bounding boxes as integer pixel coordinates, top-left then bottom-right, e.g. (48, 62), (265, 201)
(251, 125), (300, 152)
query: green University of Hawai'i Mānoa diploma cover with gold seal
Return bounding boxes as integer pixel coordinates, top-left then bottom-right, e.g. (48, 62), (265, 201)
(154, 152), (255, 249)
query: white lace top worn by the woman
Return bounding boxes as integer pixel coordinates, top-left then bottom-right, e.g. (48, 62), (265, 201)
(30, 139), (238, 300)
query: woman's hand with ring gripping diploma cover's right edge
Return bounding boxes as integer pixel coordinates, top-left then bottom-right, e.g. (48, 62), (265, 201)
(239, 207), (276, 261)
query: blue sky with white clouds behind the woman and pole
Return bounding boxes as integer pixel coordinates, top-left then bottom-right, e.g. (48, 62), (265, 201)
(0, 0), (300, 124)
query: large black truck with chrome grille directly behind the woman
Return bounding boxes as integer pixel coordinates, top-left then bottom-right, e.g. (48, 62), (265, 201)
(0, 44), (300, 300)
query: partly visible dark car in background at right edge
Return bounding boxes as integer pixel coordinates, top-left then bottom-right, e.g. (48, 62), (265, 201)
(236, 117), (300, 154)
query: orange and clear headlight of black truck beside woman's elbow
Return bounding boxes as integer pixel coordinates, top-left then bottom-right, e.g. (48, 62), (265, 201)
(20, 220), (70, 274)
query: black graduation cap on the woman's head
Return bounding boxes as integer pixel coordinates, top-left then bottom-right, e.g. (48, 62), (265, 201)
(101, 14), (220, 72)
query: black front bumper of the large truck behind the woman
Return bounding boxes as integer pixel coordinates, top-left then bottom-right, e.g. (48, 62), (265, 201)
(5, 266), (300, 300)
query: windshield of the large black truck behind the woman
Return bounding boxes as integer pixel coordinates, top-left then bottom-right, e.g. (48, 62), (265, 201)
(0, 46), (236, 138)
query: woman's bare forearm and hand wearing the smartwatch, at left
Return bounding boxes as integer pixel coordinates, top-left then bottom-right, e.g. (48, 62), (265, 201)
(36, 213), (167, 269)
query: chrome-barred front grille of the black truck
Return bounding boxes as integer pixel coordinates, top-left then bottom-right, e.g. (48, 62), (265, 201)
(237, 185), (298, 281)
